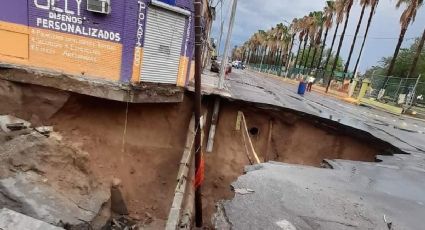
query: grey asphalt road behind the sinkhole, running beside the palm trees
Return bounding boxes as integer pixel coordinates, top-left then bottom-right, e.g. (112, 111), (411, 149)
(215, 70), (425, 153)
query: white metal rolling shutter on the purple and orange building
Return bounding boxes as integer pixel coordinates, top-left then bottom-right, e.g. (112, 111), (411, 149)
(140, 6), (186, 84)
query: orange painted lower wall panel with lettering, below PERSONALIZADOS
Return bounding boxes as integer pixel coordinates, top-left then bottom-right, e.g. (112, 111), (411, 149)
(0, 21), (122, 81)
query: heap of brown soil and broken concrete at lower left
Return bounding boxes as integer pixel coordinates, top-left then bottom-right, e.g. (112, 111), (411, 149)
(0, 116), (110, 229)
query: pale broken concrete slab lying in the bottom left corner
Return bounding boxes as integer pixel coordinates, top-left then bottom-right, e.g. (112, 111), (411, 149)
(0, 172), (109, 226)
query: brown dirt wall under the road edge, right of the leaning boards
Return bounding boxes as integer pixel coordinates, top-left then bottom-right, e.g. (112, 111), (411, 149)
(241, 107), (385, 166)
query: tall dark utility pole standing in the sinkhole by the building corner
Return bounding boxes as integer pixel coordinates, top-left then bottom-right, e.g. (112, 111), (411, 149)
(194, 0), (203, 227)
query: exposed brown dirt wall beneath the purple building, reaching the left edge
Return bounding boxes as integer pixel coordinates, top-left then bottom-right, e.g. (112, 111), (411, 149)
(0, 80), (192, 226)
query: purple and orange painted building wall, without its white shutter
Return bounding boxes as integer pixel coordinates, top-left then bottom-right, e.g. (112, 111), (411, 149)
(0, 0), (193, 86)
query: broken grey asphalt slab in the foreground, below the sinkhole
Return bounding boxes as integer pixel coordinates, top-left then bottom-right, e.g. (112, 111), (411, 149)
(216, 158), (425, 230)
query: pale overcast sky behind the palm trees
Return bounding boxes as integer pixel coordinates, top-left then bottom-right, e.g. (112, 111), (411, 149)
(212, 0), (425, 71)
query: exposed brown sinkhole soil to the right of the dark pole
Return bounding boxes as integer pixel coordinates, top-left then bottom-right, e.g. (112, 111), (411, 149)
(203, 100), (393, 225)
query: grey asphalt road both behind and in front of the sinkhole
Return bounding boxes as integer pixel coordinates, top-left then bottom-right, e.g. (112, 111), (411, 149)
(192, 70), (425, 230)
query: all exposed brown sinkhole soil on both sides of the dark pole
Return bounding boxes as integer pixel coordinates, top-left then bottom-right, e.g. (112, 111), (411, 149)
(0, 80), (398, 228)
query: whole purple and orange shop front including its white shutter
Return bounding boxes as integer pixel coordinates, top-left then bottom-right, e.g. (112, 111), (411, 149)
(0, 0), (194, 86)
